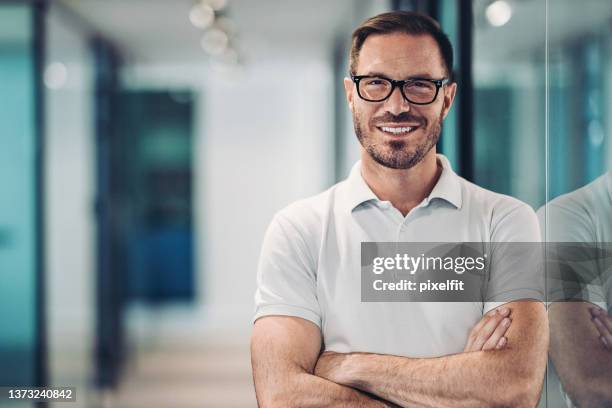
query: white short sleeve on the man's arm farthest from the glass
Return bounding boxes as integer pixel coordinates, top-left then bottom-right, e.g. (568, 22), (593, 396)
(253, 215), (321, 327)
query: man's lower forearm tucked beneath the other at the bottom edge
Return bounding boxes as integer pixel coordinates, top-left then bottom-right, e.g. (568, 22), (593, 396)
(257, 372), (393, 408)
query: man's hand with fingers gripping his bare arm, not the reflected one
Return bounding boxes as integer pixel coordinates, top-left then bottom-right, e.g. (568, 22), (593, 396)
(463, 307), (512, 353)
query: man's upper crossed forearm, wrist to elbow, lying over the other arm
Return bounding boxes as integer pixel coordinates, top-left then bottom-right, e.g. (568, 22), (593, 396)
(334, 350), (546, 408)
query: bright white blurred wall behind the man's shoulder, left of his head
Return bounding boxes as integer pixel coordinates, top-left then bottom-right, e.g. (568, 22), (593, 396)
(196, 57), (333, 331)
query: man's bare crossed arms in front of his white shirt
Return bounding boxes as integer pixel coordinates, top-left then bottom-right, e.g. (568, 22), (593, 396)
(251, 301), (548, 408)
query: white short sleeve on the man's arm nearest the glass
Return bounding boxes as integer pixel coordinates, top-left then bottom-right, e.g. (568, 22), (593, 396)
(483, 203), (546, 313)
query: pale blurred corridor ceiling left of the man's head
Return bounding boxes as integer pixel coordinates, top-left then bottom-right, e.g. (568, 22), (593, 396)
(59, 0), (360, 64)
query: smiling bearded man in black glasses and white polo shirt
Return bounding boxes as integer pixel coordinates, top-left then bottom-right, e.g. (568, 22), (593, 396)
(251, 12), (548, 407)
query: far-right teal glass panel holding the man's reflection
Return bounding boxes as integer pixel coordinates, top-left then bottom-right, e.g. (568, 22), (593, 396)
(538, 0), (612, 407)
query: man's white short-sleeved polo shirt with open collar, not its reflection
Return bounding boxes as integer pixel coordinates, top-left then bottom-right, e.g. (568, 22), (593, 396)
(254, 155), (543, 357)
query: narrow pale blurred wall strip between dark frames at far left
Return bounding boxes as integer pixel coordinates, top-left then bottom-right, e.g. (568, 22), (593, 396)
(45, 7), (95, 386)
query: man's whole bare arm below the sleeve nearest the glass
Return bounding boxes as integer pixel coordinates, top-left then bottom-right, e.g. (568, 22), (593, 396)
(315, 302), (548, 408)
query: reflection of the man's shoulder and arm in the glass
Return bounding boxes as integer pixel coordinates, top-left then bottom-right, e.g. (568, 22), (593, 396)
(538, 172), (612, 407)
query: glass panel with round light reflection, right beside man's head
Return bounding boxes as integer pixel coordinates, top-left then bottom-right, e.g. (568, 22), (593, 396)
(473, 0), (546, 208)
